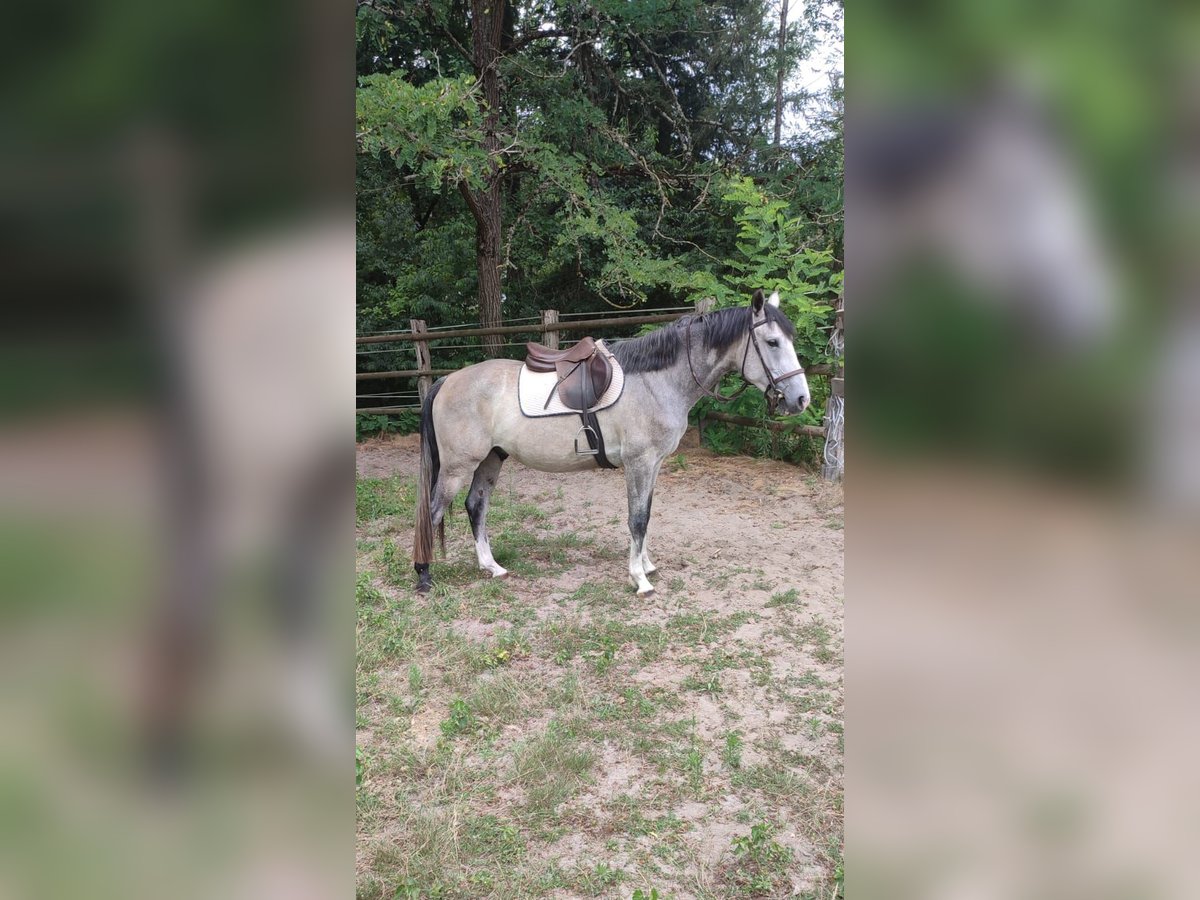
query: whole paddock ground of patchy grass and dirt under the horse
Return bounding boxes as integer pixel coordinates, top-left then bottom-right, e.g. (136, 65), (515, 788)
(356, 432), (844, 899)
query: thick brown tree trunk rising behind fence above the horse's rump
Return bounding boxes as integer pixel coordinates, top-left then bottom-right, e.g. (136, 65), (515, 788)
(460, 0), (508, 356)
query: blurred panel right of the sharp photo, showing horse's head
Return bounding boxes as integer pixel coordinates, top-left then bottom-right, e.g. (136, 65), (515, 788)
(846, 0), (1200, 898)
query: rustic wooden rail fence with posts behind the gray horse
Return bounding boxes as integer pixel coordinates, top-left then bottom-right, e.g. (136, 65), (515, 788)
(355, 302), (844, 476)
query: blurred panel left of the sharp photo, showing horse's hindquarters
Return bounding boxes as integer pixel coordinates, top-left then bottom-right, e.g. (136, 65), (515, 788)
(0, 0), (354, 898)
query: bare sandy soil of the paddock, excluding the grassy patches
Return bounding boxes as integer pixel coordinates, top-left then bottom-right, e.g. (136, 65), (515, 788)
(358, 431), (844, 898)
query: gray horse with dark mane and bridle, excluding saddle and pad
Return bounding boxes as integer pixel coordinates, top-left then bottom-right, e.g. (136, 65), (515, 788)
(413, 290), (809, 596)
